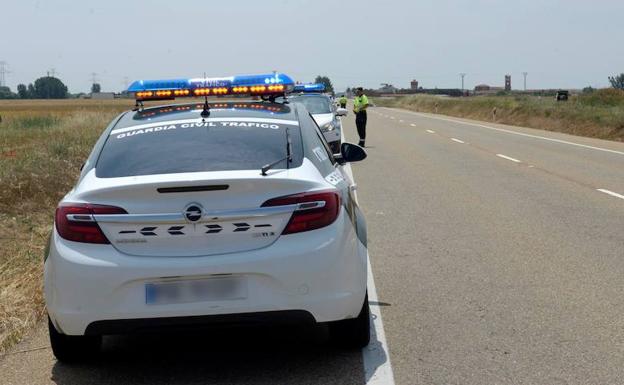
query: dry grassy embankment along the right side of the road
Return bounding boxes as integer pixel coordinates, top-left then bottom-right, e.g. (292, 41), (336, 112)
(375, 88), (624, 141)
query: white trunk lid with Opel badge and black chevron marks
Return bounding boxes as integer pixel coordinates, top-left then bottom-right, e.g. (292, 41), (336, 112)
(71, 166), (325, 257)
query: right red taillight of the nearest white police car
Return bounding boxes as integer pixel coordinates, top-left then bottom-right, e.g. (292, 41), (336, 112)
(262, 191), (340, 234)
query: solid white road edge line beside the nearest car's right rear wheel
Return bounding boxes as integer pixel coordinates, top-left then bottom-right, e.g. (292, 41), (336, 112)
(362, 258), (394, 385)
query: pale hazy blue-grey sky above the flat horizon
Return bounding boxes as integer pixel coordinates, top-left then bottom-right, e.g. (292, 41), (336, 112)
(0, 0), (624, 92)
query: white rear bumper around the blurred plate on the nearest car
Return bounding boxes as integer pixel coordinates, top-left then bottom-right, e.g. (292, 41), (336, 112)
(45, 212), (367, 335)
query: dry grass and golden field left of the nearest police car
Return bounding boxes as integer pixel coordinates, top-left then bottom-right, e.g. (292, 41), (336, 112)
(0, 100), (132, 352)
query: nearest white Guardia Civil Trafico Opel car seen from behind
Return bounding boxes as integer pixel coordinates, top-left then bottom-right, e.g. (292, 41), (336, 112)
(45, 74), (369, 361)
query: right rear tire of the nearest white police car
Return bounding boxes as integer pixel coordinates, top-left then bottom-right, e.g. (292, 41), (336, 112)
(329, 293), (370, 349)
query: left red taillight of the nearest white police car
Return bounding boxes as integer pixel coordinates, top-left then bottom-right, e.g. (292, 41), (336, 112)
(54, 203), (128, 243)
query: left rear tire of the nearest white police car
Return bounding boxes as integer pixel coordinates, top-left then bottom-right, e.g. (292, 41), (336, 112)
(48, 317), (102, 363)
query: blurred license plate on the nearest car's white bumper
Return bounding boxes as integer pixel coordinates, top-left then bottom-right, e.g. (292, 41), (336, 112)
(145, 277), (247, 305)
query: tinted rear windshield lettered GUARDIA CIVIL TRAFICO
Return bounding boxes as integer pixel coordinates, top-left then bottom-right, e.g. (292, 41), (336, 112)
(95, 118), (303, 178)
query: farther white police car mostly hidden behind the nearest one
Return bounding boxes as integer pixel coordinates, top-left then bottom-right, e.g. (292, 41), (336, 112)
(288, 83), (347, 153)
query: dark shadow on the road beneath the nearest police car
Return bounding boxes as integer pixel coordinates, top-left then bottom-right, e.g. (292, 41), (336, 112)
(52, 326), (364, 385)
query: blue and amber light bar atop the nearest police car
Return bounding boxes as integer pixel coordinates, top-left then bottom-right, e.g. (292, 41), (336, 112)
(128, 73), (295, 101)
